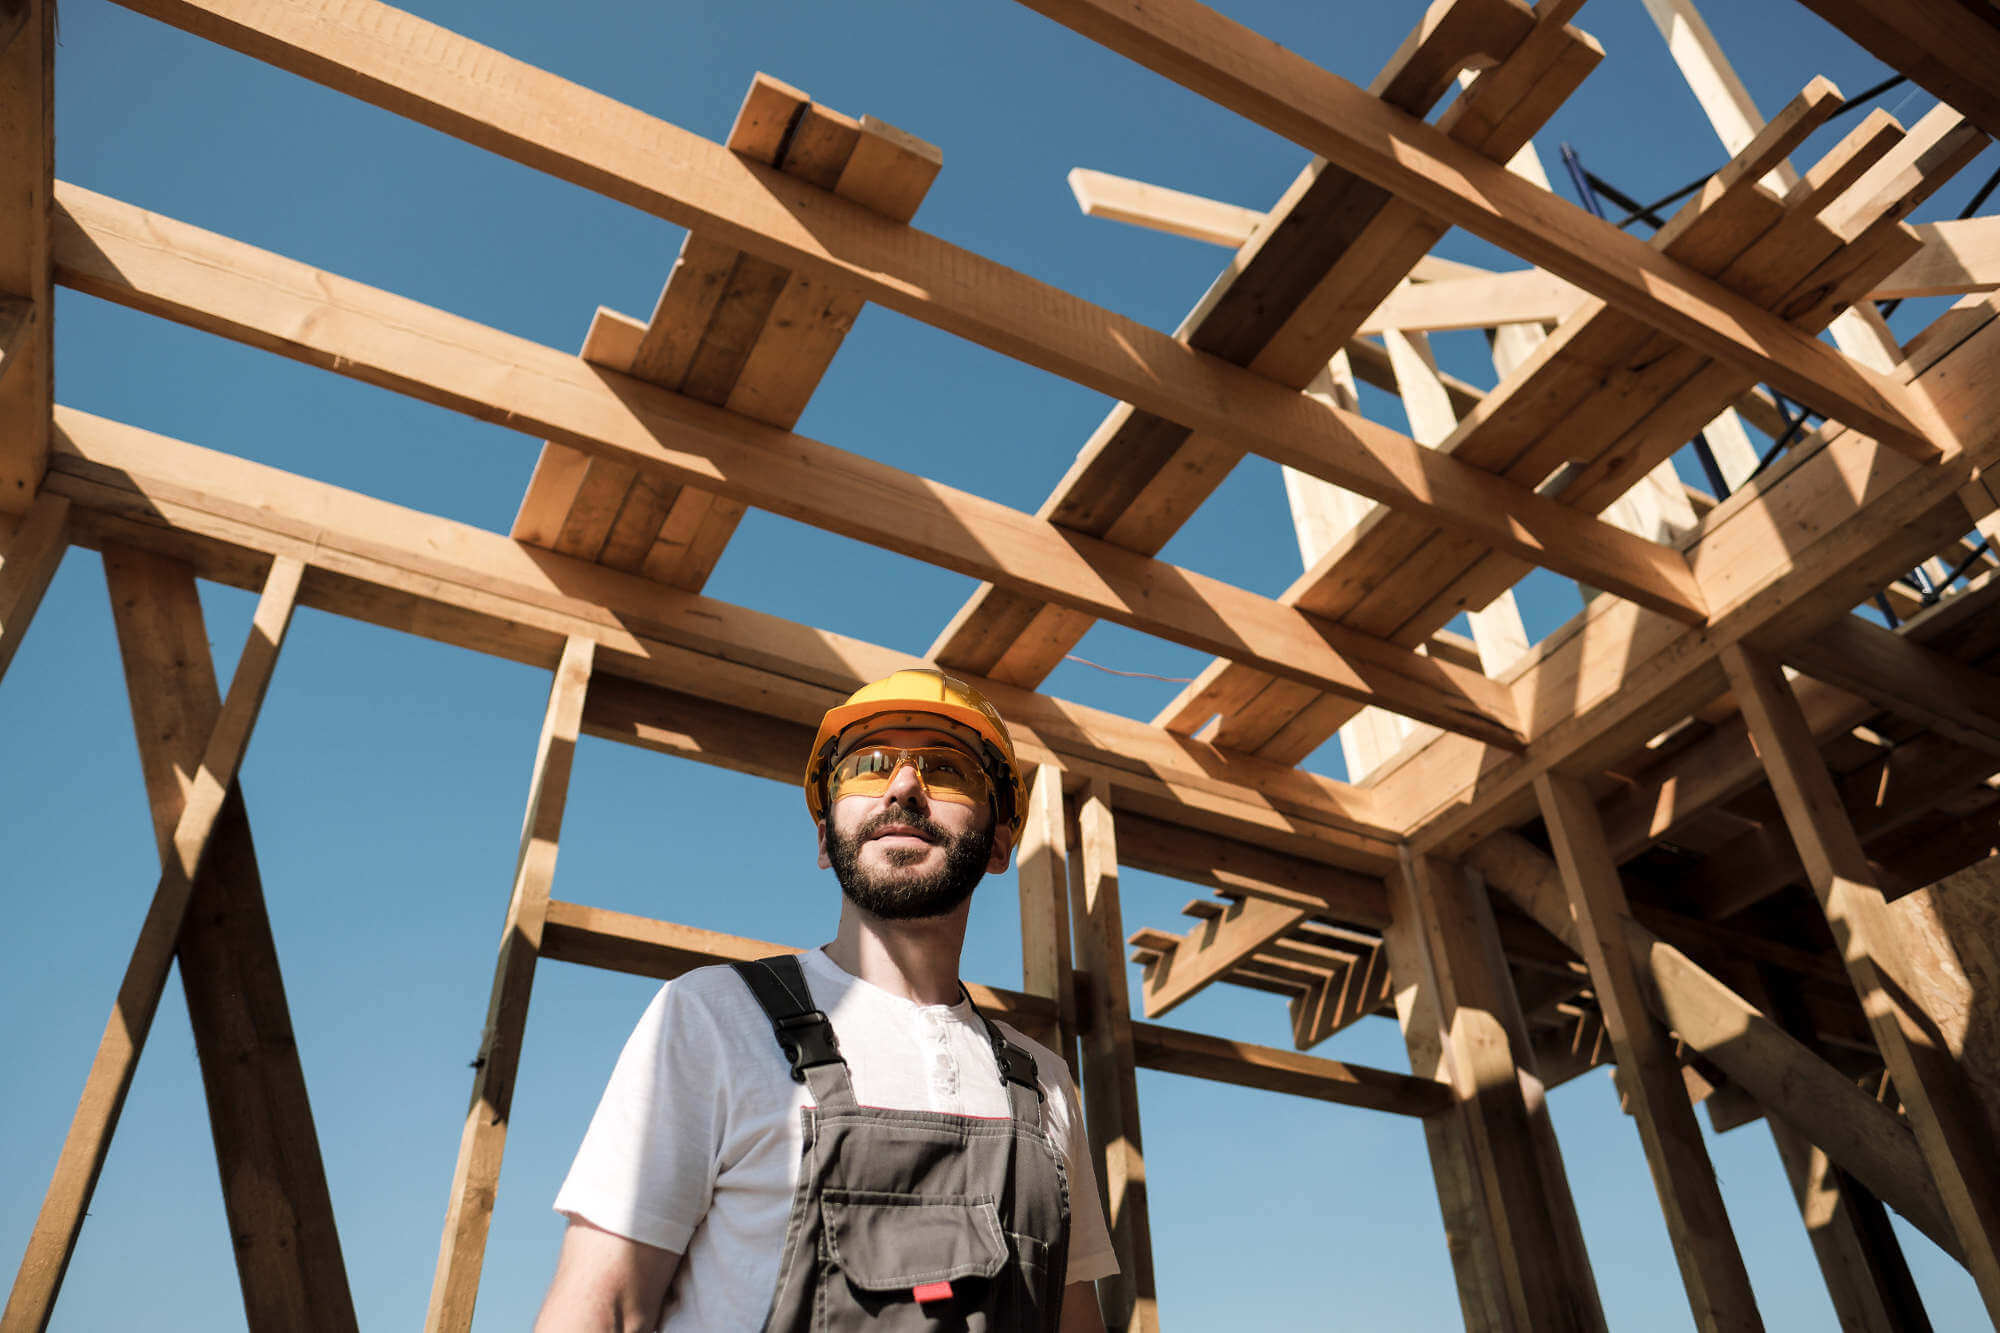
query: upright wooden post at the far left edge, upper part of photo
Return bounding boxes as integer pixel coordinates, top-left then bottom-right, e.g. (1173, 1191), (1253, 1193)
(0, 0), (56, 514)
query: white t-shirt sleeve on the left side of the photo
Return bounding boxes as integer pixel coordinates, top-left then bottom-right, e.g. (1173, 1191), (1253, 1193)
(556, 983), (726, 1253)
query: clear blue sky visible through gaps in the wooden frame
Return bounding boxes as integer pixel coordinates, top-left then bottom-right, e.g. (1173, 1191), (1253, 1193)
(0, 0), (1992, 1333)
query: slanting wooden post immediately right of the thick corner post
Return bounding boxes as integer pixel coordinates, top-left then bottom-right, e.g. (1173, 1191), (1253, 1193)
(1534, 773), (1764, 1333)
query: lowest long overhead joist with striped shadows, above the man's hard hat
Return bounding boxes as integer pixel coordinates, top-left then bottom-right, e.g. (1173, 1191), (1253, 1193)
(58, 186), (1544, 743)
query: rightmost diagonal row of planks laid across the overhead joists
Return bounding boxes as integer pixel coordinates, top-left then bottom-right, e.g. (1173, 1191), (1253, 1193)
(1160, 80), (1974, 763)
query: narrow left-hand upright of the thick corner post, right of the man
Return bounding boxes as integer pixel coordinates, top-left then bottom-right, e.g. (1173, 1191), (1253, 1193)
(1382, 856), (1514, 1333)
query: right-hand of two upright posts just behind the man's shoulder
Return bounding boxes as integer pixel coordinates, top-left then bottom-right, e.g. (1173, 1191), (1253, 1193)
(1070, 779), (1160, 1333)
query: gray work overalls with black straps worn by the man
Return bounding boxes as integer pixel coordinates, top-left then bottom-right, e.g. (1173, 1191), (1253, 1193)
(734, 957), (1070, 1333)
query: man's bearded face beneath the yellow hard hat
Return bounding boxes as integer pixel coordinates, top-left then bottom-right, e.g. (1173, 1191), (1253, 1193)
(820, 719), (1012, 921)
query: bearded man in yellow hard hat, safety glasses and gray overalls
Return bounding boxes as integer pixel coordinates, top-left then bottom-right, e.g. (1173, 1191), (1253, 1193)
(536, 671), (1118, 1333)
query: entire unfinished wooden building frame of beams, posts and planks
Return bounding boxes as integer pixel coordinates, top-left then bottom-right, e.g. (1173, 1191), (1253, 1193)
(0, 0), (2000, 1333)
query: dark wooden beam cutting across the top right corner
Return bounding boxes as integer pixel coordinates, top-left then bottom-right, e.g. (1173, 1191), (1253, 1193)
(1800, 0), (2000, 136)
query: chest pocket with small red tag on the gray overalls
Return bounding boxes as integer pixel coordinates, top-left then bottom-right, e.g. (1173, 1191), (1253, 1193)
(816, 1189), (1020, 1333)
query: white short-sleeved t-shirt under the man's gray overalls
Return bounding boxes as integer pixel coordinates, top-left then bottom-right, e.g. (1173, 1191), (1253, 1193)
(556, 949), (1118, 1331)
